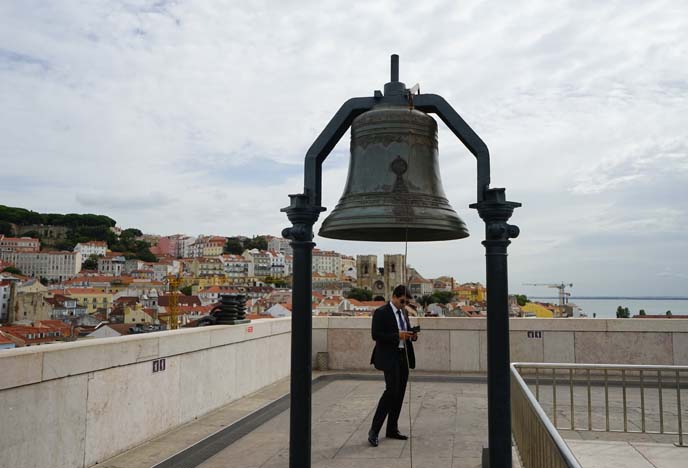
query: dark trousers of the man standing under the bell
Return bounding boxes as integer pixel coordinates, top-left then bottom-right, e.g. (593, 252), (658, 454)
(370, 349), (408, 434)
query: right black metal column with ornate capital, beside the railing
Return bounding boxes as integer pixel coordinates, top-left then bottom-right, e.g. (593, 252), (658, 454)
(471, 189), (521, 468)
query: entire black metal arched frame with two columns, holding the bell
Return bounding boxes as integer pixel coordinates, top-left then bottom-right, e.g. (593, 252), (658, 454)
(282, 55), (521, 468)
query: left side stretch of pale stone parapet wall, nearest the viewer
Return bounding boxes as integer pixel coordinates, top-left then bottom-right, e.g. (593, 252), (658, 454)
(0, 319), (291, 468)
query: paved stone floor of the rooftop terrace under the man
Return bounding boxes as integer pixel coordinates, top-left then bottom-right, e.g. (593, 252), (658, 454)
(98, 374), (688, 468)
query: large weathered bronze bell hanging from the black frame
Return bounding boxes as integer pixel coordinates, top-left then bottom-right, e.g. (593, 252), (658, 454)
(319, 105), (468, 242)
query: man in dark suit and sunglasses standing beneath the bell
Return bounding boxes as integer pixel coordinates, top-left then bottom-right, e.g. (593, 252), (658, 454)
(368, 285), (418, 447)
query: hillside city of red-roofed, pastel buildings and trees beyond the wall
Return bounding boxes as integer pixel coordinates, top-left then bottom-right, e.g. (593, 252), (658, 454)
(0, 206), (573, 348)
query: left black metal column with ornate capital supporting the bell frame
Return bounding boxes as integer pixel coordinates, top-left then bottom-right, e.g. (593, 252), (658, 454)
(282, 194), (323, 468)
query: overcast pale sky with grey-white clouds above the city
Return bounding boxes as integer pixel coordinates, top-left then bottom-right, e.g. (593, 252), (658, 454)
(0, 0), (688, 296)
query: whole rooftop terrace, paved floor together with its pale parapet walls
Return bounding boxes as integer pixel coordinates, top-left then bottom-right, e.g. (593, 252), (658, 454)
(0, 317), (688, 468)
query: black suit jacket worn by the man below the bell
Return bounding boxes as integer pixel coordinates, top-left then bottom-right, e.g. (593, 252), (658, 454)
(370, 302), (416, 371)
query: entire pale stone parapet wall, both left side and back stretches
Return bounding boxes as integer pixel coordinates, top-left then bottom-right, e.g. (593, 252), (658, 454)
(0, 317), (688, 468)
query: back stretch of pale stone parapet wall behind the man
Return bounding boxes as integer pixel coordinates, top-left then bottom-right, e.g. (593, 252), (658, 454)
(313, 317), (688, 372)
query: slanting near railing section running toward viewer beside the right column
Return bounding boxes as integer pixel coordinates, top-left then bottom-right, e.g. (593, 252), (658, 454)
(511, 364), (580, 468)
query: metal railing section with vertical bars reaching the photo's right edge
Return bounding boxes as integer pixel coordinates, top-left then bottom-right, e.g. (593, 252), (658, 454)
(512, 363), (688, 447)
